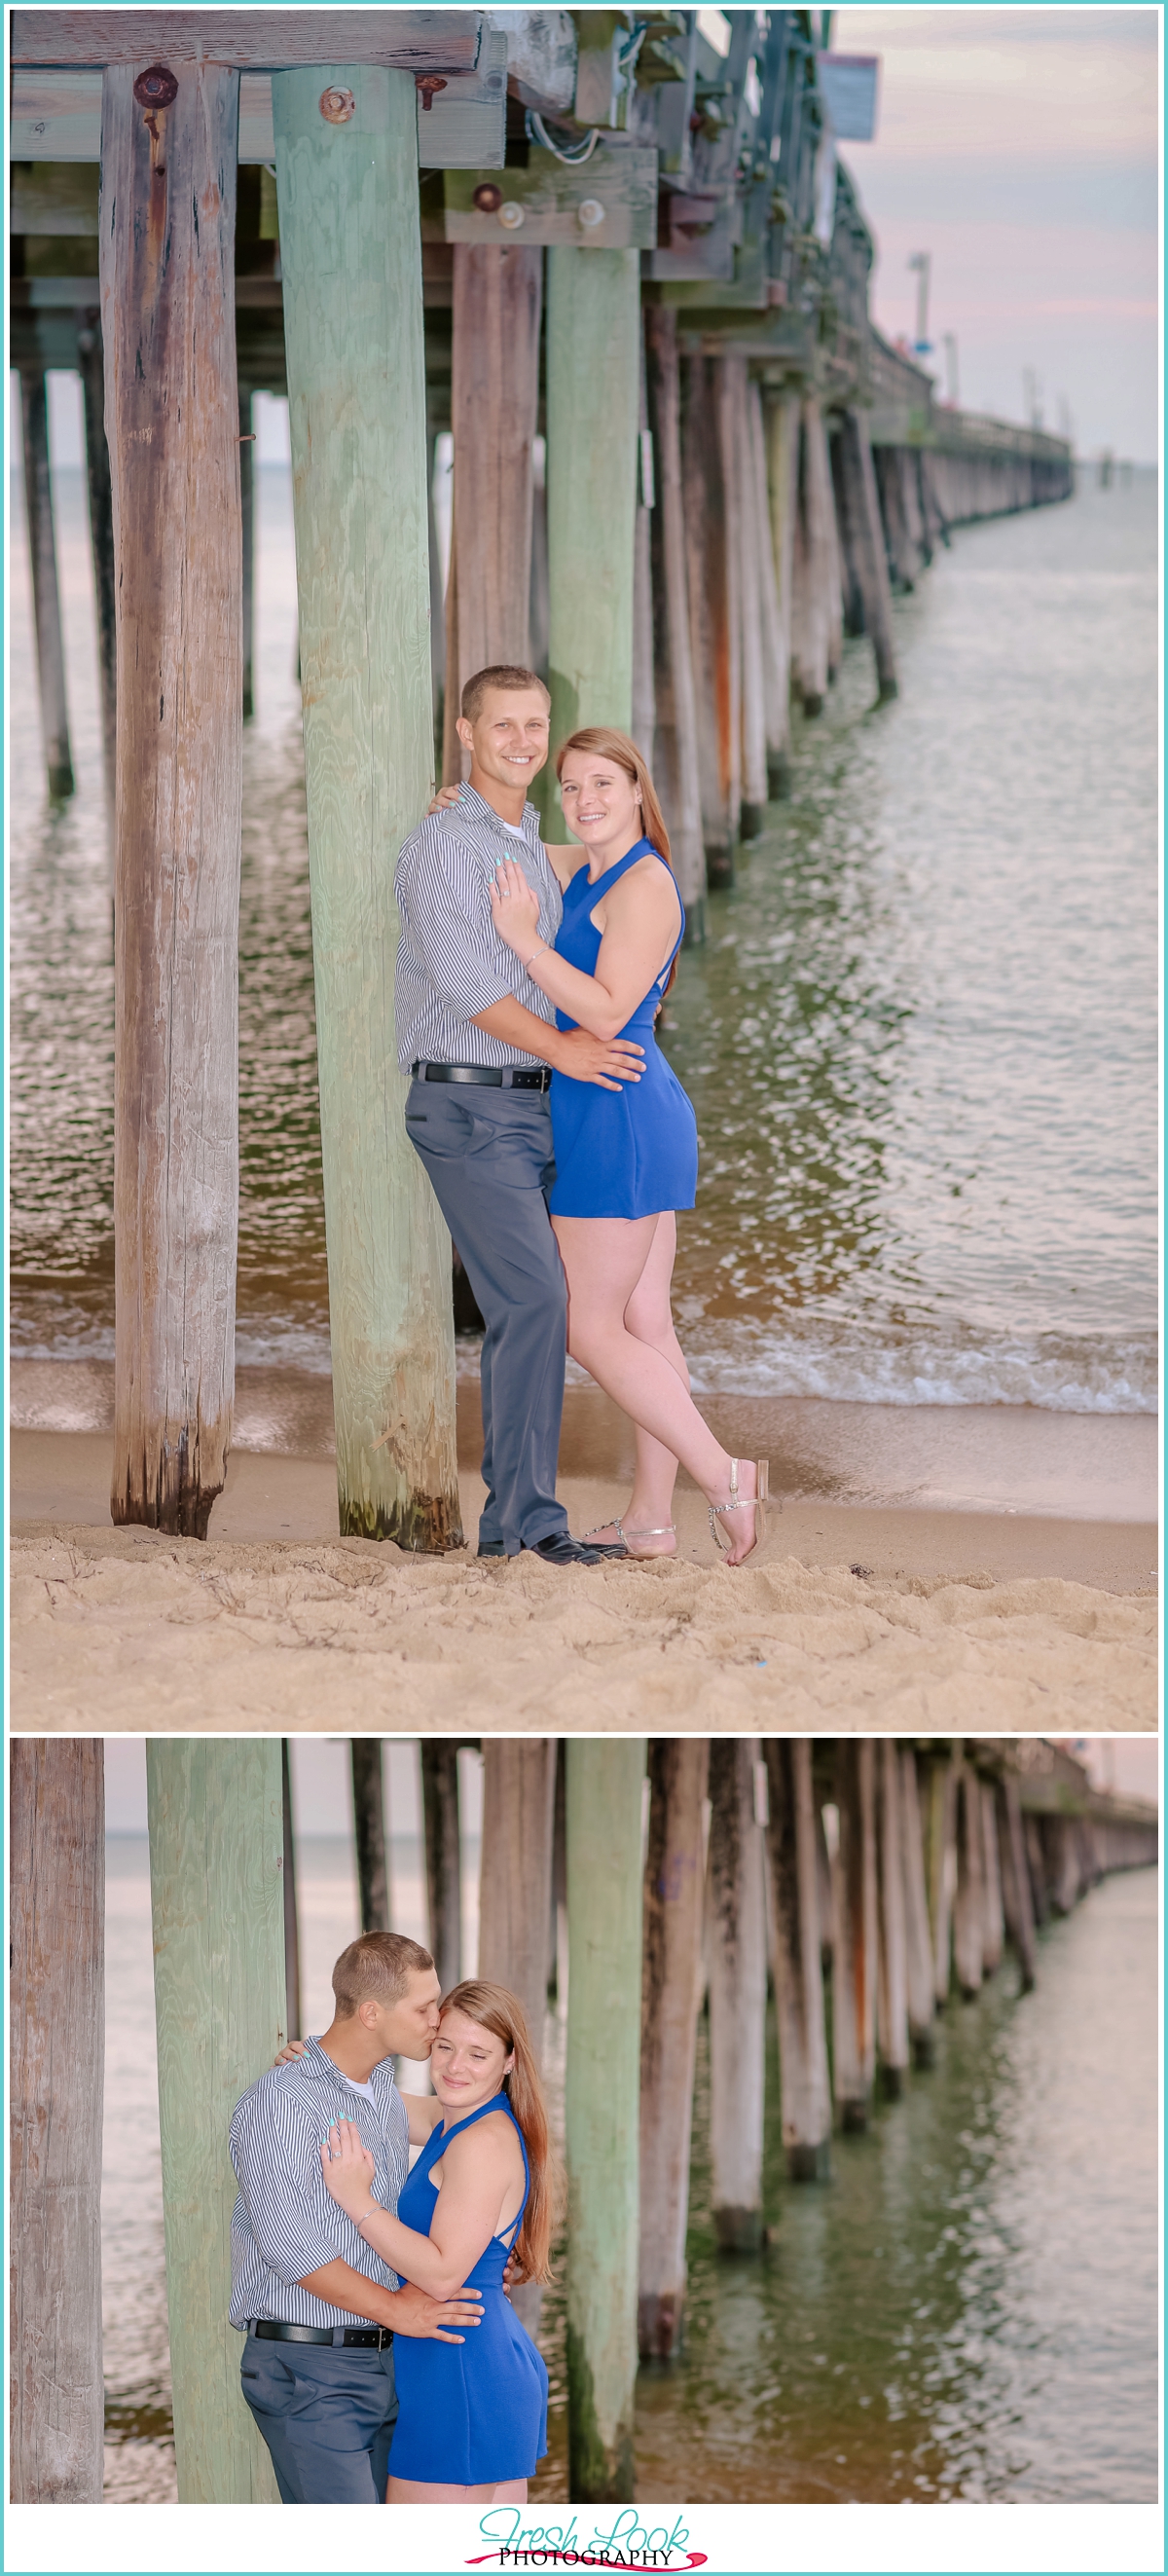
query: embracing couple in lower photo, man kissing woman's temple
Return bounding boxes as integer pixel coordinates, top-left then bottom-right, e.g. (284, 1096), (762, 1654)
(232, 1932), (553, 2504)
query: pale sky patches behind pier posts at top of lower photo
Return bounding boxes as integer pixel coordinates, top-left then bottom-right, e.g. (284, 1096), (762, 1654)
(105, 1736), (1157, 1837)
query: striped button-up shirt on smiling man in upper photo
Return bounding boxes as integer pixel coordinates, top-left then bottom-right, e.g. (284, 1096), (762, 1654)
(393, 786), (564, 1066)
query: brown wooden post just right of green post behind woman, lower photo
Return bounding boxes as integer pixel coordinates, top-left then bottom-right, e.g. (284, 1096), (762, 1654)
(639, 1736), (711, 2362)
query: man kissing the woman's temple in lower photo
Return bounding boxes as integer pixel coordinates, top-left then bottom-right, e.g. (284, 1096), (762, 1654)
(232, 1932), (481, 2504)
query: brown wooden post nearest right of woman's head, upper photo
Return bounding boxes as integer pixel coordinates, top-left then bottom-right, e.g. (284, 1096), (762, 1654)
(645, 304), (705, 945)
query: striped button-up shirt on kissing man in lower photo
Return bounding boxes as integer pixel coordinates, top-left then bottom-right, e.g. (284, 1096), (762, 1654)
(232, 2041), (409, 2326)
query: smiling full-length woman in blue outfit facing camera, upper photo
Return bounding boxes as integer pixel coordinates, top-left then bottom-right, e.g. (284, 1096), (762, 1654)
(492, 726), (767, 1566)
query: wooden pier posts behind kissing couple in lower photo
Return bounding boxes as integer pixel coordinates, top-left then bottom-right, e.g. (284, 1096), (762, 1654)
(11, 1736), (1157, 2504)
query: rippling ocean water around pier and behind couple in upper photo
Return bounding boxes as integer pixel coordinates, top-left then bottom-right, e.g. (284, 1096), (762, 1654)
(11, 469), (1157, 1412)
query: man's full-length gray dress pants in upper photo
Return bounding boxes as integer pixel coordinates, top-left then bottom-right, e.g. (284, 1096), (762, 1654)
(407, 1082), (568, 1556)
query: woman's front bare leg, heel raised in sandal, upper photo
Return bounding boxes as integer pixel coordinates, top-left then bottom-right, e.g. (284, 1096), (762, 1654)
(553, 1216), (753, 1564)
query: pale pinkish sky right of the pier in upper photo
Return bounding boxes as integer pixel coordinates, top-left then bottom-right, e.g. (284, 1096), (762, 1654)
(831, 5), (1160, 463)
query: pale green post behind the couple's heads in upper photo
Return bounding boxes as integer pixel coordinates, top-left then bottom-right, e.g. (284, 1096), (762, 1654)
(543, 244), (640, 840)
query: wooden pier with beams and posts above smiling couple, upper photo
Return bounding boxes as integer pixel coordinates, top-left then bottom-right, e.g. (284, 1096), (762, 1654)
(11, 8), (1073, 1551)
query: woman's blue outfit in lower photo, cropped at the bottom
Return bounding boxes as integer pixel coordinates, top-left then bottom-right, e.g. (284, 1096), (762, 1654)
(388, 2094), (548, 2485)
